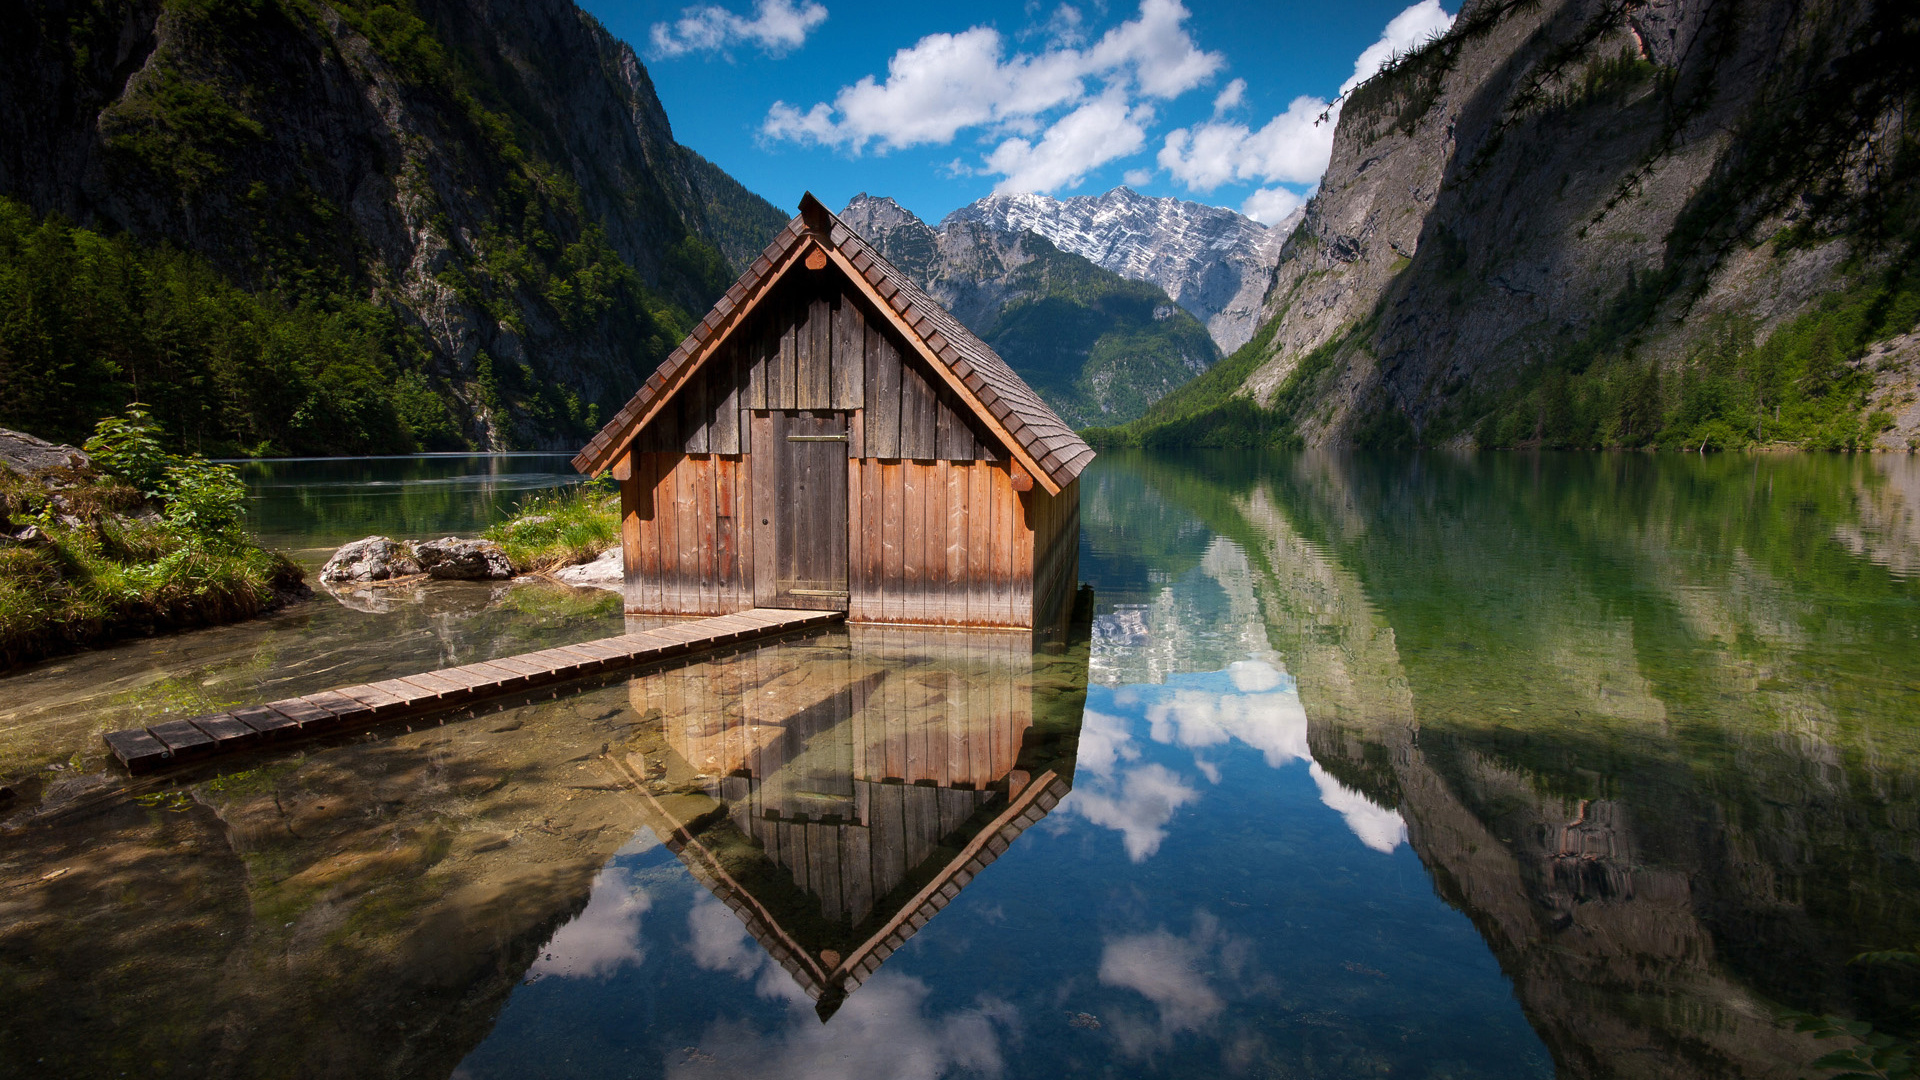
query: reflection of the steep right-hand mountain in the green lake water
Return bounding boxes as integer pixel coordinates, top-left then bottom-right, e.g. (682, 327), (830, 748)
(1094, 455), (1920, 1076)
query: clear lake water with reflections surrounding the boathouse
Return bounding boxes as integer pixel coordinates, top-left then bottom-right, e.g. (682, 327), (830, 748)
(0, 454), (1920, 1080)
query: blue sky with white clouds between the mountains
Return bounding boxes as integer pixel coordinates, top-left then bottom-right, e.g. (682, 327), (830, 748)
(582, 0), (1459, 221)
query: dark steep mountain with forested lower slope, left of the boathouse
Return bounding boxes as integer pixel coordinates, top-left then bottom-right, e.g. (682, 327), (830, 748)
(0, 0), (787, 454)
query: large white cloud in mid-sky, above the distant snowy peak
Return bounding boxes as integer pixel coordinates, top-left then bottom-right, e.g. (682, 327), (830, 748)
(760, 0), (1225, 190)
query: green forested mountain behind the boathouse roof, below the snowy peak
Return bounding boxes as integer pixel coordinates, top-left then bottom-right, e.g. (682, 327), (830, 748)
(841, 194), (1219, 427)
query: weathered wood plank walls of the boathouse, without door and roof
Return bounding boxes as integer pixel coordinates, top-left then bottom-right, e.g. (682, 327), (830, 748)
(622, 275), (1079, 626)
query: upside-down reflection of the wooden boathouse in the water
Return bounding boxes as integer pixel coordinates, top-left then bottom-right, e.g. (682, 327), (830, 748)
(624, 626), (1087, 1019)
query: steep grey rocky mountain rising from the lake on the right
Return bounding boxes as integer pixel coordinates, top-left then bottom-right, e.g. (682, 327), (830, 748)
(1106, 0), (1920, 450)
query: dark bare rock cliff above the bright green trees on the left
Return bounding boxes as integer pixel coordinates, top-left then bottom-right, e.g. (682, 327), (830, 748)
(0, 0), (785, 448)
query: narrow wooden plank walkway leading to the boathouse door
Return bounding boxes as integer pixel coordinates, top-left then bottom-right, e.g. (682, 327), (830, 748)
(106, 607), (847, 773)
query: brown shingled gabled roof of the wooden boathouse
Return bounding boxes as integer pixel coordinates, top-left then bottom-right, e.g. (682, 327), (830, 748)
(574, 194), (1094, 494)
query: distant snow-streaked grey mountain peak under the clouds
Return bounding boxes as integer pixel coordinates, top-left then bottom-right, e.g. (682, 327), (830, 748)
(941, 188), (1298, 352)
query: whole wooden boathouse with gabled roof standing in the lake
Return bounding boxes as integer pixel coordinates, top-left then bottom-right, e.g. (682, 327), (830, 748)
(574, 194), (1094, 628)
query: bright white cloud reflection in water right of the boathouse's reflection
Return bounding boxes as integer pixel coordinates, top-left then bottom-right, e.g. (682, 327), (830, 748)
(1062, 659), (1407, 849)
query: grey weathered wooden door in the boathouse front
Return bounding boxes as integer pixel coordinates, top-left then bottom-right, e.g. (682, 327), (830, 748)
(753, 411), (847, 611)
